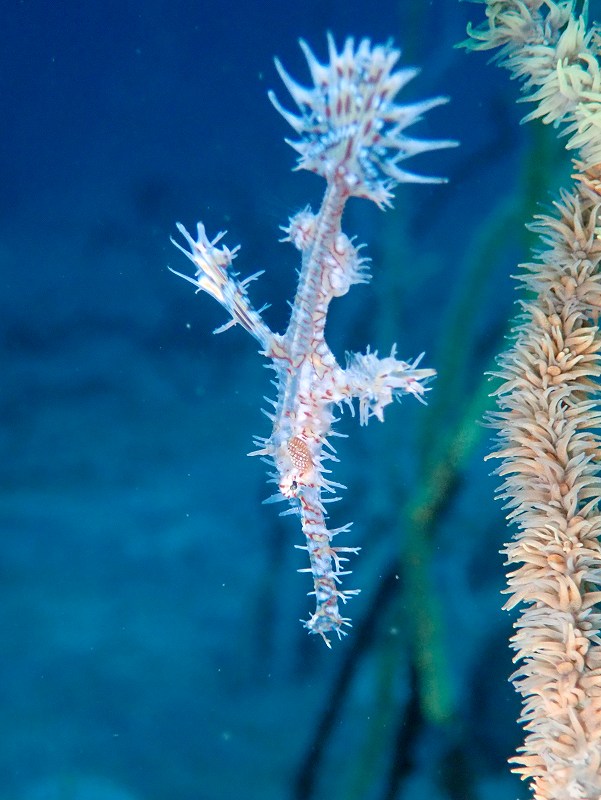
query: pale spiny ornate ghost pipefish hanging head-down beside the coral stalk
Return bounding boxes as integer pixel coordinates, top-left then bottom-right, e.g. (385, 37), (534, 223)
(171, 36), (455, 646)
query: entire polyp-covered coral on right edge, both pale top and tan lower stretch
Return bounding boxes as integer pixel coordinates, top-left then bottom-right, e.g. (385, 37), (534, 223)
(467, 0), (601, 800)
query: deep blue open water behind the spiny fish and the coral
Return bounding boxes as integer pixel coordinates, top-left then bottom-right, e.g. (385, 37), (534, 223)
(0, 0), (594, 800)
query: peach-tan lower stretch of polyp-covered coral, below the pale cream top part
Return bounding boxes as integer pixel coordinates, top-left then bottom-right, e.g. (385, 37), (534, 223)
(494, 190), (601, 800)
